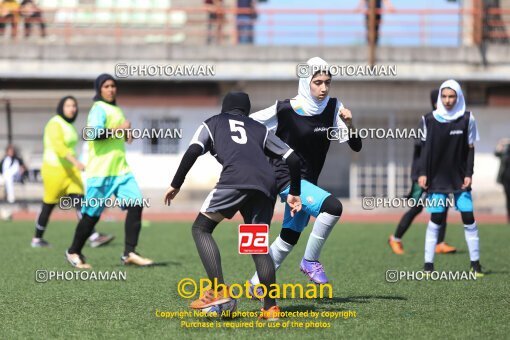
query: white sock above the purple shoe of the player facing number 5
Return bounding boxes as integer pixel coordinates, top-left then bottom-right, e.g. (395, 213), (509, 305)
(304, 212), (340, 261)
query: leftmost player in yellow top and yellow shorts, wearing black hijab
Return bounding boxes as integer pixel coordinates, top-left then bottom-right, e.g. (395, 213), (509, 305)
(31, 96), (113, 248)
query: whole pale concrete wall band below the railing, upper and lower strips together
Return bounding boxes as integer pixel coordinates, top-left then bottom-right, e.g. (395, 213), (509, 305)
(0, 44), (510, 81)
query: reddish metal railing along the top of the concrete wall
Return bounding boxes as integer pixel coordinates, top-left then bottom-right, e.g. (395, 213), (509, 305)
(0, 4), (510, 46)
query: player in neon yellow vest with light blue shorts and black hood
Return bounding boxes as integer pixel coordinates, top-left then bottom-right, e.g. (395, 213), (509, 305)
(66, 74), (154, 269)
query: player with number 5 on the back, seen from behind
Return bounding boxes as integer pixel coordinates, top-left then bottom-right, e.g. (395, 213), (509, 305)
(165, 92), (301, 319)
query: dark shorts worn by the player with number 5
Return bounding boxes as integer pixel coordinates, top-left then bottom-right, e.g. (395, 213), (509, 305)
(200, 188), (276, 225)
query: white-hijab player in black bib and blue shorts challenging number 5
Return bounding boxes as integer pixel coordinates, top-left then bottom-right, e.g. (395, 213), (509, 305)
(250, 57), (361, 285)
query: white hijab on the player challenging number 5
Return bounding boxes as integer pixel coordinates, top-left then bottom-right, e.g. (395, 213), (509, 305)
(291, 57), (329, 116)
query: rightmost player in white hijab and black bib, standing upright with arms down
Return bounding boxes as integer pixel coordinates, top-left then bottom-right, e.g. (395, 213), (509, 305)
(418, 80), (483, 276)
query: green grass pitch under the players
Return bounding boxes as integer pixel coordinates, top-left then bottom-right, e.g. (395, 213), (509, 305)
(0, 222), (510, 339)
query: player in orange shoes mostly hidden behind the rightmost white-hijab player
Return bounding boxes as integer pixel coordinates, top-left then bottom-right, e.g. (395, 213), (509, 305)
(388, 89), (457, 255)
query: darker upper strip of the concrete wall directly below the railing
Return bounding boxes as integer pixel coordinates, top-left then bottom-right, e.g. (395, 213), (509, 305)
(0, 42), (510, 64)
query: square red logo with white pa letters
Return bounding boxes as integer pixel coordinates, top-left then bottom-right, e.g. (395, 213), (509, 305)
(239, 224), (269, 254)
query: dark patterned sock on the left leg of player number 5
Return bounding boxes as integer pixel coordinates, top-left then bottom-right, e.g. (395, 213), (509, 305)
(191, 214), (225, 289)
